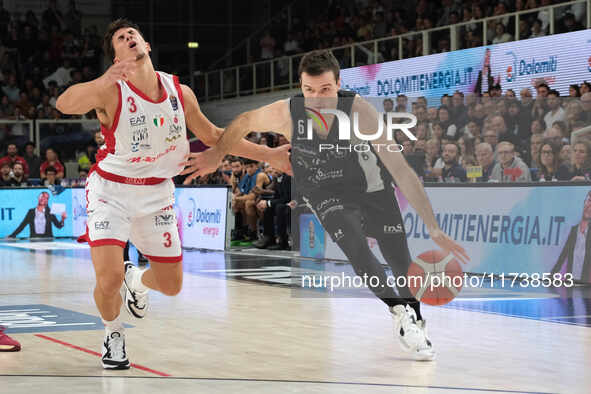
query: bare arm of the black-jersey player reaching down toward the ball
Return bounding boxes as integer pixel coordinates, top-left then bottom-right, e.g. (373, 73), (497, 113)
(354, 97), (470, 263)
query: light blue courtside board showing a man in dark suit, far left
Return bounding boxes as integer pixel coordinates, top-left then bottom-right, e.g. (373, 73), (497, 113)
(0, 186), (72, 238)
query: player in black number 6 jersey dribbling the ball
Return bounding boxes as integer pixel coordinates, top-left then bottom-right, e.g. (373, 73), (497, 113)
(185, 50), (468, 360)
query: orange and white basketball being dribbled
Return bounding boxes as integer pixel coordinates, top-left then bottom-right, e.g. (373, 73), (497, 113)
(407, 250), (463, 305)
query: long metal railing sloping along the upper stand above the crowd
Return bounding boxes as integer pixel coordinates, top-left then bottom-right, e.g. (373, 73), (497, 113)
(197, 0), (591, 101)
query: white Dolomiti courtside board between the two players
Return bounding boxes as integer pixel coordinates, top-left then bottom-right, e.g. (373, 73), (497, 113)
(174, 187), (228, 250)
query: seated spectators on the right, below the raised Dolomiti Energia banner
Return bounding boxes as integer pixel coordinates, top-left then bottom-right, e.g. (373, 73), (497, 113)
(383, 77), (591, 183)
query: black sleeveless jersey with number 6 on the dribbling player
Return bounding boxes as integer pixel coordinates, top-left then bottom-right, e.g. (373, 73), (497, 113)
(289, 90), (392, 195)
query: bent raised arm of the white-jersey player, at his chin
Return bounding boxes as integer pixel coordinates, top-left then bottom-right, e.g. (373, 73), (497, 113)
(56, 59), (136, 115)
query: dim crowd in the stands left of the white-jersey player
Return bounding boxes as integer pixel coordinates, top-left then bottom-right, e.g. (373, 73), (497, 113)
(0, 0), (102, 162)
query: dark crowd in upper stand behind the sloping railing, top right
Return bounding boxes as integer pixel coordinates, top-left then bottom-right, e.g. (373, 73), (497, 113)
(259, 0), (586, 67)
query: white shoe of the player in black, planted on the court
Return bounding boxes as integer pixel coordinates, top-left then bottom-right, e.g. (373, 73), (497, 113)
(390, 305), (435, 361)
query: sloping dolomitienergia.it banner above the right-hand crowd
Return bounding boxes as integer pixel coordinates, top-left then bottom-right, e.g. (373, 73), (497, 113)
(341, 30), (591, 105)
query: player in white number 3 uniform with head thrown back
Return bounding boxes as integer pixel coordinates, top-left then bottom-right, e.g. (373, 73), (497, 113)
(57, 19), (289, 369)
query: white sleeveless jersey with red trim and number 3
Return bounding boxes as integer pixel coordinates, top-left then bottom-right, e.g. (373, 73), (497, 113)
(97, 71), (189, 179)
